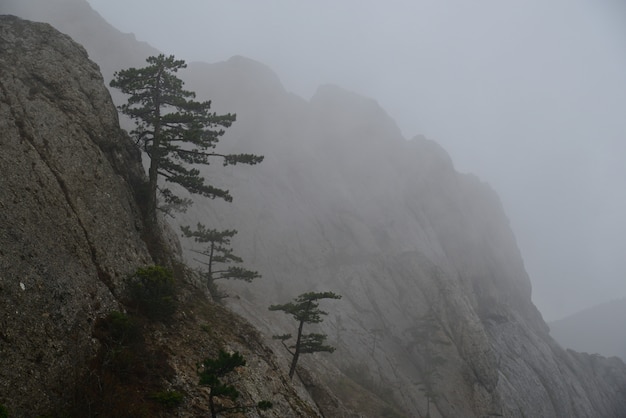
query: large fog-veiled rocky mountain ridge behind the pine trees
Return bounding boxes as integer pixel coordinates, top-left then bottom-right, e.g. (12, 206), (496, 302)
(0, 0), (626, 417)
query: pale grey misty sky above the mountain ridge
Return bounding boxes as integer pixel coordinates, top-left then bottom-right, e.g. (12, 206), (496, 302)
(88, 0), (626, 320)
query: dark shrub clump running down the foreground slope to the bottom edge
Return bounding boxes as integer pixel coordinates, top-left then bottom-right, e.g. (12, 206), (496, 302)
(70, 266), (178, 417)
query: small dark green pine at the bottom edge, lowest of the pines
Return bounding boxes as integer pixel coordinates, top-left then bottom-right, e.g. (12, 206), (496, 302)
(198, 350), (273, 418)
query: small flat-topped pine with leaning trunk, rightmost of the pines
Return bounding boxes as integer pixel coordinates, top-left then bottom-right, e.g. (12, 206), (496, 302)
(269, 292), (341, 379)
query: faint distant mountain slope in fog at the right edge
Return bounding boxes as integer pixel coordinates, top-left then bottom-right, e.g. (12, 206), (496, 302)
(548, 299), (626, 361)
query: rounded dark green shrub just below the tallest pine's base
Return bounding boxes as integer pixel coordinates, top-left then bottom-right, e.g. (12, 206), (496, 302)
(128, 266), (176, 321)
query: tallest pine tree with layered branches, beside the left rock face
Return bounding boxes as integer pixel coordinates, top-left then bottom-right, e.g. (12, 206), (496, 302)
(110, 55), (263, 227)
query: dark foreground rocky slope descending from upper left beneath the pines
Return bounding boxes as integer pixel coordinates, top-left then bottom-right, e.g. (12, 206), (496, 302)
(0, 16), (324, 417)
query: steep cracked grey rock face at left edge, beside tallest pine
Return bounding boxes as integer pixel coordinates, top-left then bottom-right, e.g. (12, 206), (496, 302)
(0, 16), (150, 415)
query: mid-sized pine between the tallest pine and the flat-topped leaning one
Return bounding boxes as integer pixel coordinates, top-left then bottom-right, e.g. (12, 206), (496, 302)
(181, 223), (261, 298)
